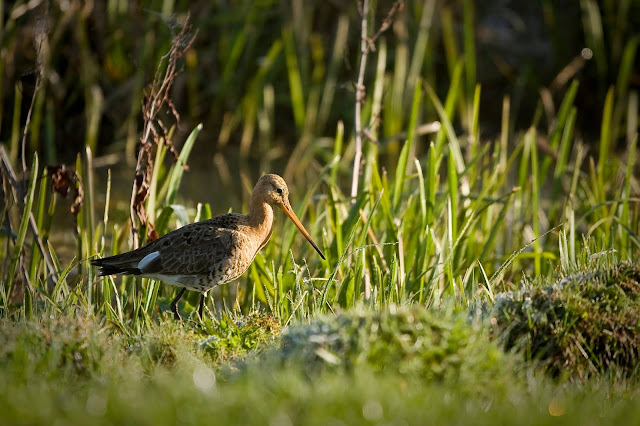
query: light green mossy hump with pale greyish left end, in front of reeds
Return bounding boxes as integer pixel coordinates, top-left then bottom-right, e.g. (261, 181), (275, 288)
(266, 306), (512, 384)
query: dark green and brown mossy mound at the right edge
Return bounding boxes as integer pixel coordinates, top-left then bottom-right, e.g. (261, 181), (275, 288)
(492, 263), (640, 380)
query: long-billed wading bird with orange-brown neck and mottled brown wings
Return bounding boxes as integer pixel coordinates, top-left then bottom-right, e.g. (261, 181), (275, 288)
(91, 174), (324, 318)
